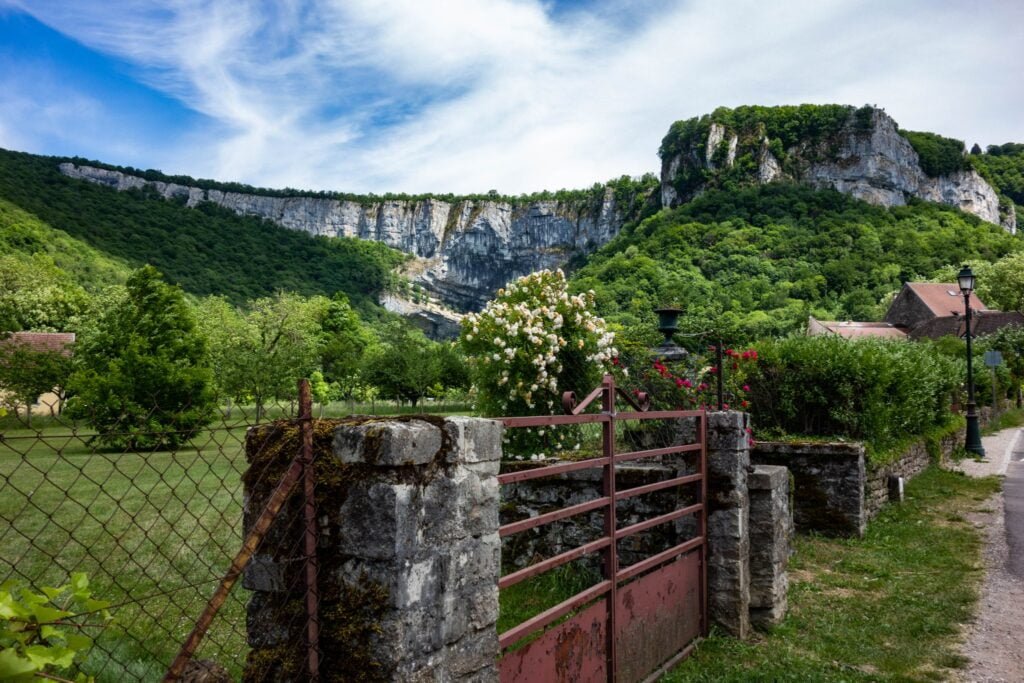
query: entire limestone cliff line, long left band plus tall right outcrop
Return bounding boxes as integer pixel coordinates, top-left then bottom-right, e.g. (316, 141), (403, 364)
(60, 104), (1016, 317)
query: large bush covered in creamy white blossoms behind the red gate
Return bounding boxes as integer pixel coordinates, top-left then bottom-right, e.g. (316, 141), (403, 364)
(460, 270), (617, 455)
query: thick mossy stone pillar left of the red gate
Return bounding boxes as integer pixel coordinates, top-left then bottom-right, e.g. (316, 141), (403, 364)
(245, 418), (502, 683)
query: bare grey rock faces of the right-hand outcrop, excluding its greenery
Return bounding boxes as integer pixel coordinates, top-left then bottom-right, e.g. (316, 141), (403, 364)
(662, 110), (1017, 232)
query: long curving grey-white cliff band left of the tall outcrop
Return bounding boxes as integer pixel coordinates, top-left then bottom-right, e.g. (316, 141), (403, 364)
(60, 163), (624, 309)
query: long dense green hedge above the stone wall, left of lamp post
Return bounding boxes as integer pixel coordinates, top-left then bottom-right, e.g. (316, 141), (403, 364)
(751, 337), (963, 451)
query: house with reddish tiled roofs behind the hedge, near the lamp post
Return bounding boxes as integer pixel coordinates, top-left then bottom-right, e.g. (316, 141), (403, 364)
(807, 283), (1024, 339)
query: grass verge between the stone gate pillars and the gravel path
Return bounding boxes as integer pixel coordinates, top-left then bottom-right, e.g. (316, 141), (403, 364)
(663, 466), (1000, 683)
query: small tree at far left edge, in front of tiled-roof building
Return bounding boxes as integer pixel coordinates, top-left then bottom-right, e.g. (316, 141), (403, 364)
(0, 341), (71, 427)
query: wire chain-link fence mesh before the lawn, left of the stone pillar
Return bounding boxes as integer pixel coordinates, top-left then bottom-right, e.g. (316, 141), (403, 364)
(0, 382), (327, 681)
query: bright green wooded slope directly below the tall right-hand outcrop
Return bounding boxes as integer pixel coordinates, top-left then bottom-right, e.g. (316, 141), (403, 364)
(572, 183), (1024, 339)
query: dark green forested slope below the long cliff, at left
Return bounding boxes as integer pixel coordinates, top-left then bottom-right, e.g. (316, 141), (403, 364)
(0, 151), (406, 309)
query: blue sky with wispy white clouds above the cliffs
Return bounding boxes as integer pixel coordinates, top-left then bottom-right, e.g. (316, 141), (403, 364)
(0, 0), (1024, 195)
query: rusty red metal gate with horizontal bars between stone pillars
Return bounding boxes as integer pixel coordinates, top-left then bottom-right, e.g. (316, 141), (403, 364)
(499, 375), (708, 683)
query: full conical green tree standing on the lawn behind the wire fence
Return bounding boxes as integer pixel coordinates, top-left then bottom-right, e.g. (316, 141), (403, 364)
(69, 265), (214, 450)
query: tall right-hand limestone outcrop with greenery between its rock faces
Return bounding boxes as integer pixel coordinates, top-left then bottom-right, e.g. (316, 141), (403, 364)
(662, 108), (1017, 232)
